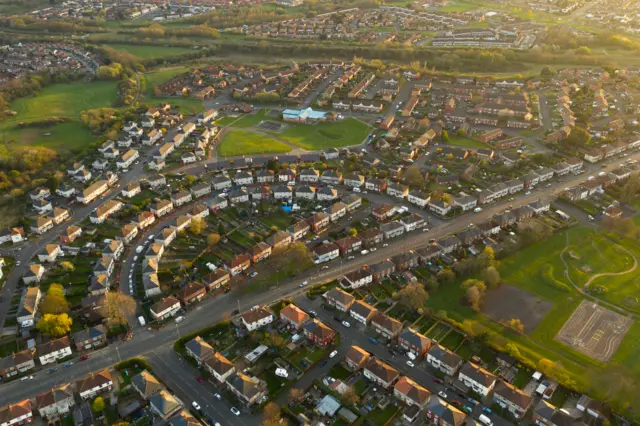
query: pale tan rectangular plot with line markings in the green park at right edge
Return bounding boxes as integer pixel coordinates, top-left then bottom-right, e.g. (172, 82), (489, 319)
(556, 300), (632, 362)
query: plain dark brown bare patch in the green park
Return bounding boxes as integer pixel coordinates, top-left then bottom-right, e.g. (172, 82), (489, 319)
(482, 285), (552, 334)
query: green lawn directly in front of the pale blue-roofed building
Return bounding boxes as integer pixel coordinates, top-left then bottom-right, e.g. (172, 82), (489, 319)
(278, 118), (371, 150)
